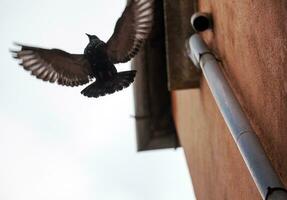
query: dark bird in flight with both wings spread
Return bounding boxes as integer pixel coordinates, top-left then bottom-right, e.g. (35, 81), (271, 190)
(10, 0), (154, 98)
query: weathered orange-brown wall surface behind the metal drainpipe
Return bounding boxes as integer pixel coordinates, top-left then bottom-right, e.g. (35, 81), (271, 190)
(173, 0), (287, 200)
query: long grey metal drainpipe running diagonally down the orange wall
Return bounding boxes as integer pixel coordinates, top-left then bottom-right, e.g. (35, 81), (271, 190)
(188, 34), (287, 200)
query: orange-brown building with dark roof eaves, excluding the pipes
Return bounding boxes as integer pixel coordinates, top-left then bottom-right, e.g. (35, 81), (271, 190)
(134, 0), (287, 200)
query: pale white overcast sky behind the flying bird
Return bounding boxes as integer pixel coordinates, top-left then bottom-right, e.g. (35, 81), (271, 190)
(0, 0), (197, 200)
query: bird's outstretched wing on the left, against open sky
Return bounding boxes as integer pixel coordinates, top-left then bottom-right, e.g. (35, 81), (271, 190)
(11, 44), (92, 86)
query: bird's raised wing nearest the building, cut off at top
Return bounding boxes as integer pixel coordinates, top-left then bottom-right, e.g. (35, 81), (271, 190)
(107, 0), (153, 63)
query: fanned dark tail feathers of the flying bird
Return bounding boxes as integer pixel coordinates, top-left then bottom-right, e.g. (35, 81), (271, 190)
(81, 70), (136, 98)
